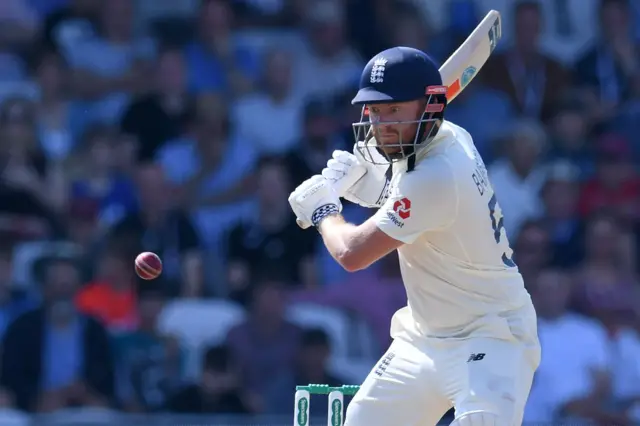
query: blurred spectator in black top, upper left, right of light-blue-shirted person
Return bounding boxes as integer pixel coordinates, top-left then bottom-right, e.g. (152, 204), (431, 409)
(121, 47), (194, 161)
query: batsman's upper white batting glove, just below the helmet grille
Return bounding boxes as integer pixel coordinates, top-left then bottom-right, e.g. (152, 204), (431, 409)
(322, 142), (390, 208)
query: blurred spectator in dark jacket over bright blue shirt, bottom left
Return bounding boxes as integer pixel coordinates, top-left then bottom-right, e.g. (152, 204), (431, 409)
(1, 258), (114, 412)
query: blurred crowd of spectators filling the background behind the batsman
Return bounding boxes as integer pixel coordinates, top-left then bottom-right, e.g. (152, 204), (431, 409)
(0, 0), (640, 425)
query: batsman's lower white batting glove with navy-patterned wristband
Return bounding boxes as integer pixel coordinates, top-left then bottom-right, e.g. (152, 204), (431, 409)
(289, 175), (342, 229)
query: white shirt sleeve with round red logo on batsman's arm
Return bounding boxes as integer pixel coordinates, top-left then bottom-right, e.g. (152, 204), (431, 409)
(374, 157), (458, 244)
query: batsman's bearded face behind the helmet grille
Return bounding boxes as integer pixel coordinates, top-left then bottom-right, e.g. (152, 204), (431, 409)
(368, 100), (424, 154)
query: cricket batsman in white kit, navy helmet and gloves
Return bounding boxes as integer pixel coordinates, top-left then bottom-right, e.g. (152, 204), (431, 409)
(289, 47), (540, 426)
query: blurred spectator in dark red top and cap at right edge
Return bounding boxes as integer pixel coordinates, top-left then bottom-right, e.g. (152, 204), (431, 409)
(580, 135), (640, 224)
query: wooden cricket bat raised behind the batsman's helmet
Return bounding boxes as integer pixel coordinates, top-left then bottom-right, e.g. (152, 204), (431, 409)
(296, 10), (502, 229)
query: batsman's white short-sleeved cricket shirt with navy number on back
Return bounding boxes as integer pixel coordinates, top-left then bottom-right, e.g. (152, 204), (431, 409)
(374, 121), (531, 337)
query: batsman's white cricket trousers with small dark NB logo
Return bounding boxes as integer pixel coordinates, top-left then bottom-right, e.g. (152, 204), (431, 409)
(345, 306), (540, 426)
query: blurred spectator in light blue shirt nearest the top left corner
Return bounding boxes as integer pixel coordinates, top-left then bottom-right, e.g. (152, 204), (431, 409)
(67, 0), (155, 125)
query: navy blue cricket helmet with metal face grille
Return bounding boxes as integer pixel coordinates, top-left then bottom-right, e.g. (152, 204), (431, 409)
(351, 46), (447, 168)
